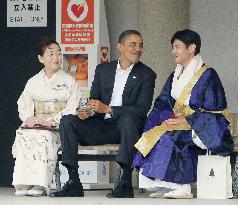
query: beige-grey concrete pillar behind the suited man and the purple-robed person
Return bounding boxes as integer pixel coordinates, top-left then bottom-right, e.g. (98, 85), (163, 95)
(105, 0), (189, 96)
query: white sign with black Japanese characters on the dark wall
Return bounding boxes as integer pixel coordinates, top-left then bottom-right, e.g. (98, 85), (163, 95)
(7, 0), (47, 27)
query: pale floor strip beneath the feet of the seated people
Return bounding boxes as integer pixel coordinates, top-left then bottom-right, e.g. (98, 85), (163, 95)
(0, 188), (238, 205)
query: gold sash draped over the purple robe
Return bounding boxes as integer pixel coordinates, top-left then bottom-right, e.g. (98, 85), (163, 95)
(134, 65), (230, 157)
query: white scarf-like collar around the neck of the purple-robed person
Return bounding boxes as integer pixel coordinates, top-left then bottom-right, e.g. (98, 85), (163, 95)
(171, 55), (203, 100)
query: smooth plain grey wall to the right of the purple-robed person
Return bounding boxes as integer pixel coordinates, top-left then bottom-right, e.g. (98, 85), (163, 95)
(190, 0), (238, 113)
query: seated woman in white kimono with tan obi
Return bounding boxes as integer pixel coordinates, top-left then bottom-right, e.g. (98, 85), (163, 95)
(12, 39), (80, 196)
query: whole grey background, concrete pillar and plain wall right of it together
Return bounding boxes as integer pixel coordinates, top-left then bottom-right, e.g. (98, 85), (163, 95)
(105, 0), (238, 113)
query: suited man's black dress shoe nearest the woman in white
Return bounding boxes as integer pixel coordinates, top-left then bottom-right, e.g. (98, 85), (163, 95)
(49, 180), (84, 197)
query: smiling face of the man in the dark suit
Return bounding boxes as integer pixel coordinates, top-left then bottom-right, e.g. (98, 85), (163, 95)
(117, 34), (143, 69)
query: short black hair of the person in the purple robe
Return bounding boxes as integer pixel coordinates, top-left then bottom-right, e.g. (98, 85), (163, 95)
(171, 29), (201, 55)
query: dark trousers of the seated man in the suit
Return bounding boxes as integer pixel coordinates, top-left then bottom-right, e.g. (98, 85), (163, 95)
(60, 113), (144, 169)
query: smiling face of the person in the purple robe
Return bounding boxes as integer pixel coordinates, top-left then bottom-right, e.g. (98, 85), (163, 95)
(172, 39), (196, 68)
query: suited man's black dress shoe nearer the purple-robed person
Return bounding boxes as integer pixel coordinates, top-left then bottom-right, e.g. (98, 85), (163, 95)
(106, 180), (134, 198)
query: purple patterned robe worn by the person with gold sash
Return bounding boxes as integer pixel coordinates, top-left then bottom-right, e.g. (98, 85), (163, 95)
(132, 68), (233, 184)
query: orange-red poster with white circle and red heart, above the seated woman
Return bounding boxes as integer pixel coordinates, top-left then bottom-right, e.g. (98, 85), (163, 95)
(61, 0), (94, 44)
